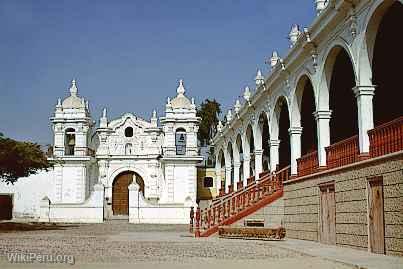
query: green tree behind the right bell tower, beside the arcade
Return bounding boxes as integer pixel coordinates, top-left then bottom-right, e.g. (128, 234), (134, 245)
(197, 99), (221, 145)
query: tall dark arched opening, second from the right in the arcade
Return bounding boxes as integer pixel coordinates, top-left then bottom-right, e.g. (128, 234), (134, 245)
(327, 47), (358, 144)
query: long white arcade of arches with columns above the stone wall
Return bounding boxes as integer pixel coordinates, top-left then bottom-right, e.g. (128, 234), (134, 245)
(213, 1), (403, 191)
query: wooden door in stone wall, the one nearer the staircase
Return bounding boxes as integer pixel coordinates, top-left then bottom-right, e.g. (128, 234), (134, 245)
(319, 183), (336, 245)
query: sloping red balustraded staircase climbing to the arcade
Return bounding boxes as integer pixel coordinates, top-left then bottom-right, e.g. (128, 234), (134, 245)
(195, 166), (290, 237)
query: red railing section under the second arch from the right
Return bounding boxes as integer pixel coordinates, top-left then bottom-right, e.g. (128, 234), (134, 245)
(326, 135), (360, 169)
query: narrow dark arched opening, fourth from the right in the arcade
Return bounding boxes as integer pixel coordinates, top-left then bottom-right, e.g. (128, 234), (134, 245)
(277, 97), (291, 169)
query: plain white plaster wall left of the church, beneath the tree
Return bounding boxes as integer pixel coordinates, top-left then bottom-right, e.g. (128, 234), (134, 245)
(0, 170), (54, 218)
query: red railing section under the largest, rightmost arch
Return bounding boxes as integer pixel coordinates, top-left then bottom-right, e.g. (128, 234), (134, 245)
(368, 116), (403, 158)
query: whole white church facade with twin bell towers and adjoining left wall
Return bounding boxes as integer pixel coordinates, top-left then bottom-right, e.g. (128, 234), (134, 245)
(0, 80), (203, 223)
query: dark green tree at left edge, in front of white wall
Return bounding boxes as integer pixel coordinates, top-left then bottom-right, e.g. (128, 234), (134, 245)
(0, 133), (51, 184)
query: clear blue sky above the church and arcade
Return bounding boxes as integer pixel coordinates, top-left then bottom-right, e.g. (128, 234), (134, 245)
(0, 0), (315, 144)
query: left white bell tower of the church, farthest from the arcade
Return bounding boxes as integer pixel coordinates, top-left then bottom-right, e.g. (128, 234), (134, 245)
(50, 80), (94, 203)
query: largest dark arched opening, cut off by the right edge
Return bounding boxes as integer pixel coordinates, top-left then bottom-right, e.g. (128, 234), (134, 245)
(372, 1), (403, 126)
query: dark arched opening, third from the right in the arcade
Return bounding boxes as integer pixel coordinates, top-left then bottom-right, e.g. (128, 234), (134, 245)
(297, 77), (318, 155)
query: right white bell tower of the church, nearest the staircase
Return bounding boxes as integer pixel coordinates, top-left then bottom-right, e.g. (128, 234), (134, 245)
(161, 80), (203, 207)
